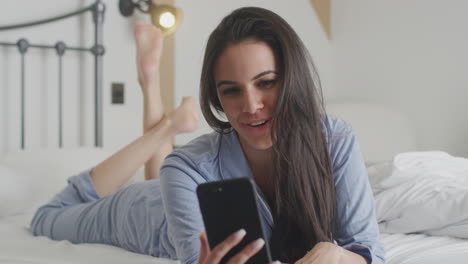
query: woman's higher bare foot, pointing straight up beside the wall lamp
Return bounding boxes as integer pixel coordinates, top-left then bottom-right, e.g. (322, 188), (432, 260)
(134, 21), (163, 94)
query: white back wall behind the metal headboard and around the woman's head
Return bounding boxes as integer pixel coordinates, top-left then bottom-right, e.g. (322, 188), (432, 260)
(0, 0), (333, 156)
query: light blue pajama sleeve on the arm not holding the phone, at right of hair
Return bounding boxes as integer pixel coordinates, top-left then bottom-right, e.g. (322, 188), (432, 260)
(330, 121), (385, 264)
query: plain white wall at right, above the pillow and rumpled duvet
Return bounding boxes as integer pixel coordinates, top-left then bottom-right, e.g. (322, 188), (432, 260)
(332, 0), (468, 157)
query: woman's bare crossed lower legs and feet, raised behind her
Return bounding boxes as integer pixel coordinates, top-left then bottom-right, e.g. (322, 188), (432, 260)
(91, 23), (198, 197)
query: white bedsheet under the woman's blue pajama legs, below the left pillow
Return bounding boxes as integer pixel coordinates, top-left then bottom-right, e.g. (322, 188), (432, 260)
(0, 213), (179, 264)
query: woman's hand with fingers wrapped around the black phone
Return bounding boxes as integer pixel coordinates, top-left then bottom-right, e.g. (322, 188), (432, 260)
(198, 229), (276, 264)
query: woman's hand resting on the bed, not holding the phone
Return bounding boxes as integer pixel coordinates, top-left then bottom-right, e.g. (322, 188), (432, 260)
(295, 242), (345, 264)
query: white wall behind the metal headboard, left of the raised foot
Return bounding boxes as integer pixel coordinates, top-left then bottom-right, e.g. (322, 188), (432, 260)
(0, 0), (149, 156)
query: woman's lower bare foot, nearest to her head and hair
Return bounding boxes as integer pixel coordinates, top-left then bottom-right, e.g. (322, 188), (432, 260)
(168, 96), (200, 134)
